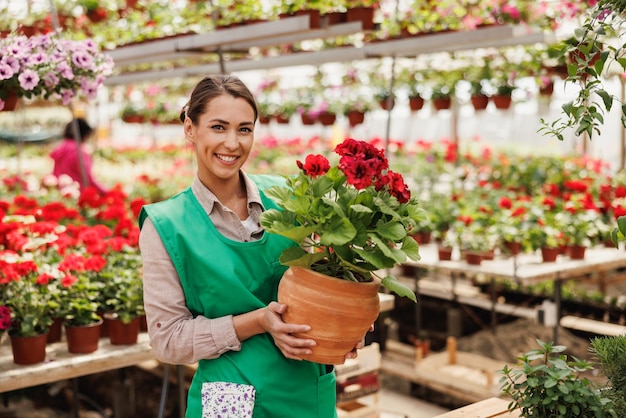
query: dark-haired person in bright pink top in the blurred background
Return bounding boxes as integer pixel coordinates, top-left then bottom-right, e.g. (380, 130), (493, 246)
(50, 117), (107, 194)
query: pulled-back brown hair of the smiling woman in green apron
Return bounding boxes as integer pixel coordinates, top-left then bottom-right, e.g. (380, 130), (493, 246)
(180, 74), (259, 125)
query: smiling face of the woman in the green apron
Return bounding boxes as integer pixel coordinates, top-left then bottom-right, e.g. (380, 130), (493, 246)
(185, 94), (254, 186)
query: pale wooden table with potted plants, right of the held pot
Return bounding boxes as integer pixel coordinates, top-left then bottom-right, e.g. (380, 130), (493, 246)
(404, 244), (626, 343)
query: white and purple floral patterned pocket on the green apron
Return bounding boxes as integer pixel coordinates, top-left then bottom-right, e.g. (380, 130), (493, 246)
(202, 382), (256, 418)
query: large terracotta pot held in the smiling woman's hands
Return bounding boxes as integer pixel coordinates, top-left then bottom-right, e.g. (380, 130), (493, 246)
(278, 266), (380, 364)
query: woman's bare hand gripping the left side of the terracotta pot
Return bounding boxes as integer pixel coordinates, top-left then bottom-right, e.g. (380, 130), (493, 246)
(262, 302), (316, 360)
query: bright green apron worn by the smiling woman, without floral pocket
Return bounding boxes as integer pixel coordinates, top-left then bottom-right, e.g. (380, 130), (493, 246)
(139, 182), (337, 418)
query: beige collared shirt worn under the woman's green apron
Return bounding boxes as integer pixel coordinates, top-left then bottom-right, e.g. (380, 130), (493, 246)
(139, 173), (263, 364)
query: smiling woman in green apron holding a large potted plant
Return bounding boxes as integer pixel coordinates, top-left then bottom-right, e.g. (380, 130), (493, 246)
(139, 75), (361, 418)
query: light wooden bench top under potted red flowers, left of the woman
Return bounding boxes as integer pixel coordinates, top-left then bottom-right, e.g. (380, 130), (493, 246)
(0, 333), (154, 393)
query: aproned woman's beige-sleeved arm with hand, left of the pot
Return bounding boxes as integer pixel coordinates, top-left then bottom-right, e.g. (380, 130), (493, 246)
(139, 218), (315, 364)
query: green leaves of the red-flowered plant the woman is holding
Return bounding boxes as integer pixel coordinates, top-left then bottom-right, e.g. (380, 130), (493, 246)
(261, 141), (425, 301)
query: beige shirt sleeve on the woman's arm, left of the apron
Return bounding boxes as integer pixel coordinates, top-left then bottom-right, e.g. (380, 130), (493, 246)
(139, 218), (241, 364)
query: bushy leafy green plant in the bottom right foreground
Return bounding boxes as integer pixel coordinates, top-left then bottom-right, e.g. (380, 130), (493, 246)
(500, 340), (618, 418)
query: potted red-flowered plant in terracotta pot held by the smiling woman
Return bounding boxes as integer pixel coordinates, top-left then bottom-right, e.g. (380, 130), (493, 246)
(261, 138), (422, 364)
